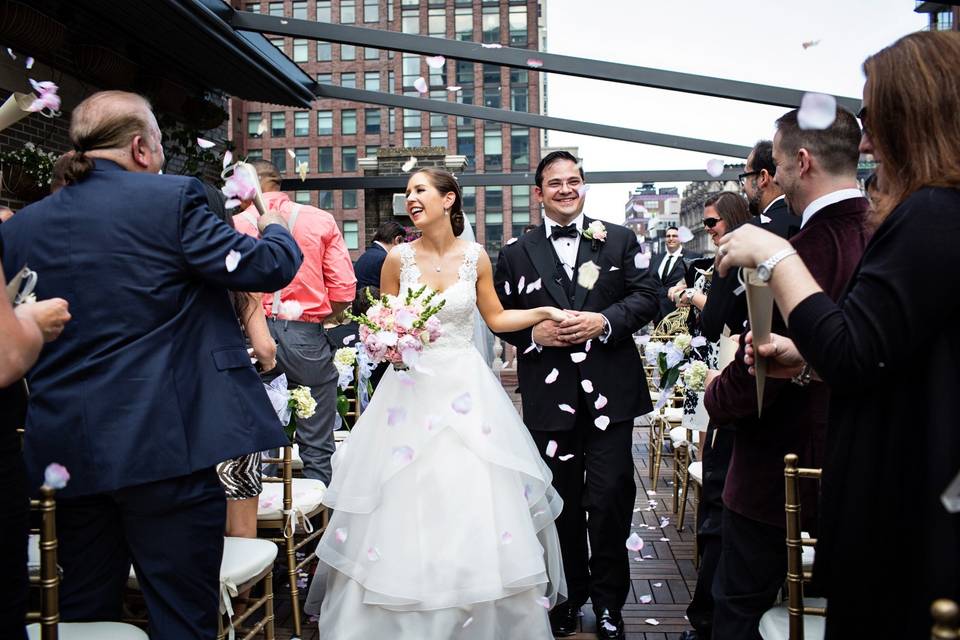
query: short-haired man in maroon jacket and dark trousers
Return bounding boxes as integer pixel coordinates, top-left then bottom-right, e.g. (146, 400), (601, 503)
(705, 108), (868, 640)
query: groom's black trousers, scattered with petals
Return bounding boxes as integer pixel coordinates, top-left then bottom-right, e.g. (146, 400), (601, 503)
(530, 394), (637, 611)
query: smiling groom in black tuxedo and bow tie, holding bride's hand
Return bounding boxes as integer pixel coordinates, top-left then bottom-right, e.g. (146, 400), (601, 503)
(494, 151), (658, 639)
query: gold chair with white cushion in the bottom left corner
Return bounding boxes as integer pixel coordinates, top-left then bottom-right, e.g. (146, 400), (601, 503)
(27, 487), (148, 640)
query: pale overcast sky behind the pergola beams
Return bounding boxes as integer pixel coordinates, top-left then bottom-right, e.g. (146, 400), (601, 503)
(544, 0), (927, 222)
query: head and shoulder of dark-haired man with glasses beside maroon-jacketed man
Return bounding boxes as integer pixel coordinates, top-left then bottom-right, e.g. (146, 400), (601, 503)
(740, 140), (800, 240)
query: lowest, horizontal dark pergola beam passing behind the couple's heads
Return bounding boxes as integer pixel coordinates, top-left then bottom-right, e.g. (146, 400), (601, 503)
(280, 167), (741, 191)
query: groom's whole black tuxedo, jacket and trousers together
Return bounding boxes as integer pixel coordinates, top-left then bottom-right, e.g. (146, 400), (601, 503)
(494, 217), (658, 611)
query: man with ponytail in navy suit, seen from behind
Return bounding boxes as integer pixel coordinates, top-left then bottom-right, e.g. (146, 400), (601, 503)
(2, 91), (302, 640)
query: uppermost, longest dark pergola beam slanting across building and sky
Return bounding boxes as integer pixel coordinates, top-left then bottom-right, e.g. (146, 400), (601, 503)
(230, 11), (860, 113)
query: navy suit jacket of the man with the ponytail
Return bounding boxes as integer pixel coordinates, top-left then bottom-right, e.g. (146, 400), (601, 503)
(0, 160), (302, 496)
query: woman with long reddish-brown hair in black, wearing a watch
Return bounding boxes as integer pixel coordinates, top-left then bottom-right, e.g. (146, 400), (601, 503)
(720, 32), (960, 640)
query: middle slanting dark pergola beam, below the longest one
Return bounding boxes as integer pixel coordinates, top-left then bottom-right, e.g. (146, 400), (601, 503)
(316, 84), (751, 158)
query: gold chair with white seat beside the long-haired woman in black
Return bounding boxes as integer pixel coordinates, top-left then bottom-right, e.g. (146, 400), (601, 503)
(760, 453), (827, 640)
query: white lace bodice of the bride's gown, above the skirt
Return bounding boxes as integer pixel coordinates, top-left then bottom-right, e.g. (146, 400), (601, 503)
(400, 243), (483, 353)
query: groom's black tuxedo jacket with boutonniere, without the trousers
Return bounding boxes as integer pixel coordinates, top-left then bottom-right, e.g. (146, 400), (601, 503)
(494, 216), (658, 431)
